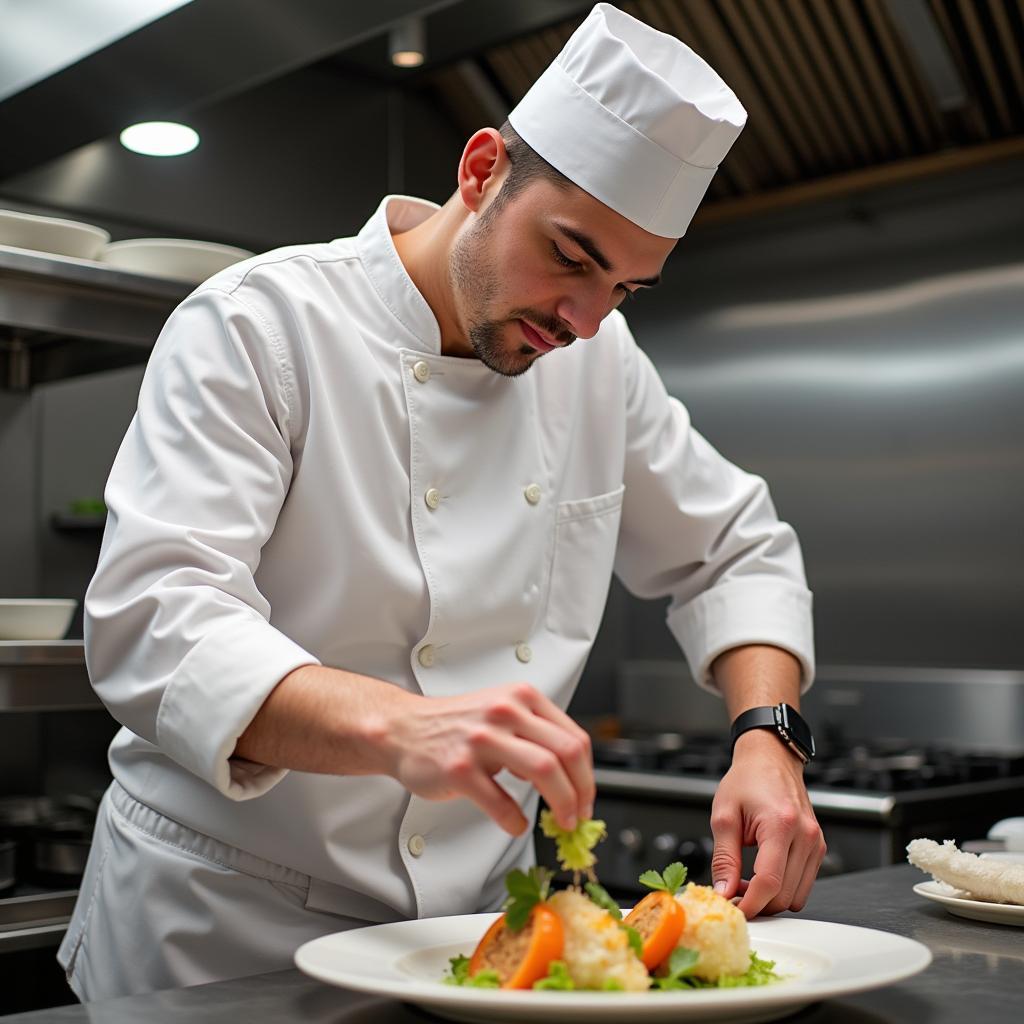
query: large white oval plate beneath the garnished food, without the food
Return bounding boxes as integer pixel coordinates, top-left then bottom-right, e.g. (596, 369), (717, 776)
(295, 913), (932, 1024)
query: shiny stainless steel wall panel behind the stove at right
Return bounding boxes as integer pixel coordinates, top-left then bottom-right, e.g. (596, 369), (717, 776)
(624, 160), (1024, 668)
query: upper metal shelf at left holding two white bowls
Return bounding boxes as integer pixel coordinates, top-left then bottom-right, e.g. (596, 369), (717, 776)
(0, 246), (195, 391)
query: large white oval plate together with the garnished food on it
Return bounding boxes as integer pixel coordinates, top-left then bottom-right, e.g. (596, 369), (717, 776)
(295, 814), (932, 1024)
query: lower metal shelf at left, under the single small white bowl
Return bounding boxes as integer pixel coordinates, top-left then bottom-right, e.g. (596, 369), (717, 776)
(0, 640), (103, 712)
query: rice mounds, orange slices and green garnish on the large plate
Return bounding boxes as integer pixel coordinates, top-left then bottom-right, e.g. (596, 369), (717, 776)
(444, 811), (781, 992)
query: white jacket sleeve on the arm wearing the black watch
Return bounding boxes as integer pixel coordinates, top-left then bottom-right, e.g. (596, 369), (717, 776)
(615, 321), (814, 692)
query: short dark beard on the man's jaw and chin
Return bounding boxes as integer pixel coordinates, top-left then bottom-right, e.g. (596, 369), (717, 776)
(449, 204), (546, 377)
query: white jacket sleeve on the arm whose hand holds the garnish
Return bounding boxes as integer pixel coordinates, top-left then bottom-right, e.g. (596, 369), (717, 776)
(85, 288), (318, 800)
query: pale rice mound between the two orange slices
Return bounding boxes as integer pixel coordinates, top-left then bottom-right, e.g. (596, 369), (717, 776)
(548, 889), (647, 992)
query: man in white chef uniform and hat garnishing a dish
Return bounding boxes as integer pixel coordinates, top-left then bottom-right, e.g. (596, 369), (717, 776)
(58, 3), (824, 999)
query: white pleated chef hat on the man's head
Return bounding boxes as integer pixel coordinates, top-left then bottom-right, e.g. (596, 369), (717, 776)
(509, 3), (746, 239)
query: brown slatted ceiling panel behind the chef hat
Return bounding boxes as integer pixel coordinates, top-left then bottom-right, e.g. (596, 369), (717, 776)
(437, 0), (1024, 205)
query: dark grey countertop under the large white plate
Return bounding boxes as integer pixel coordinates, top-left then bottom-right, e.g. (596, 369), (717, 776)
(4, 864), (1024, 1024)
